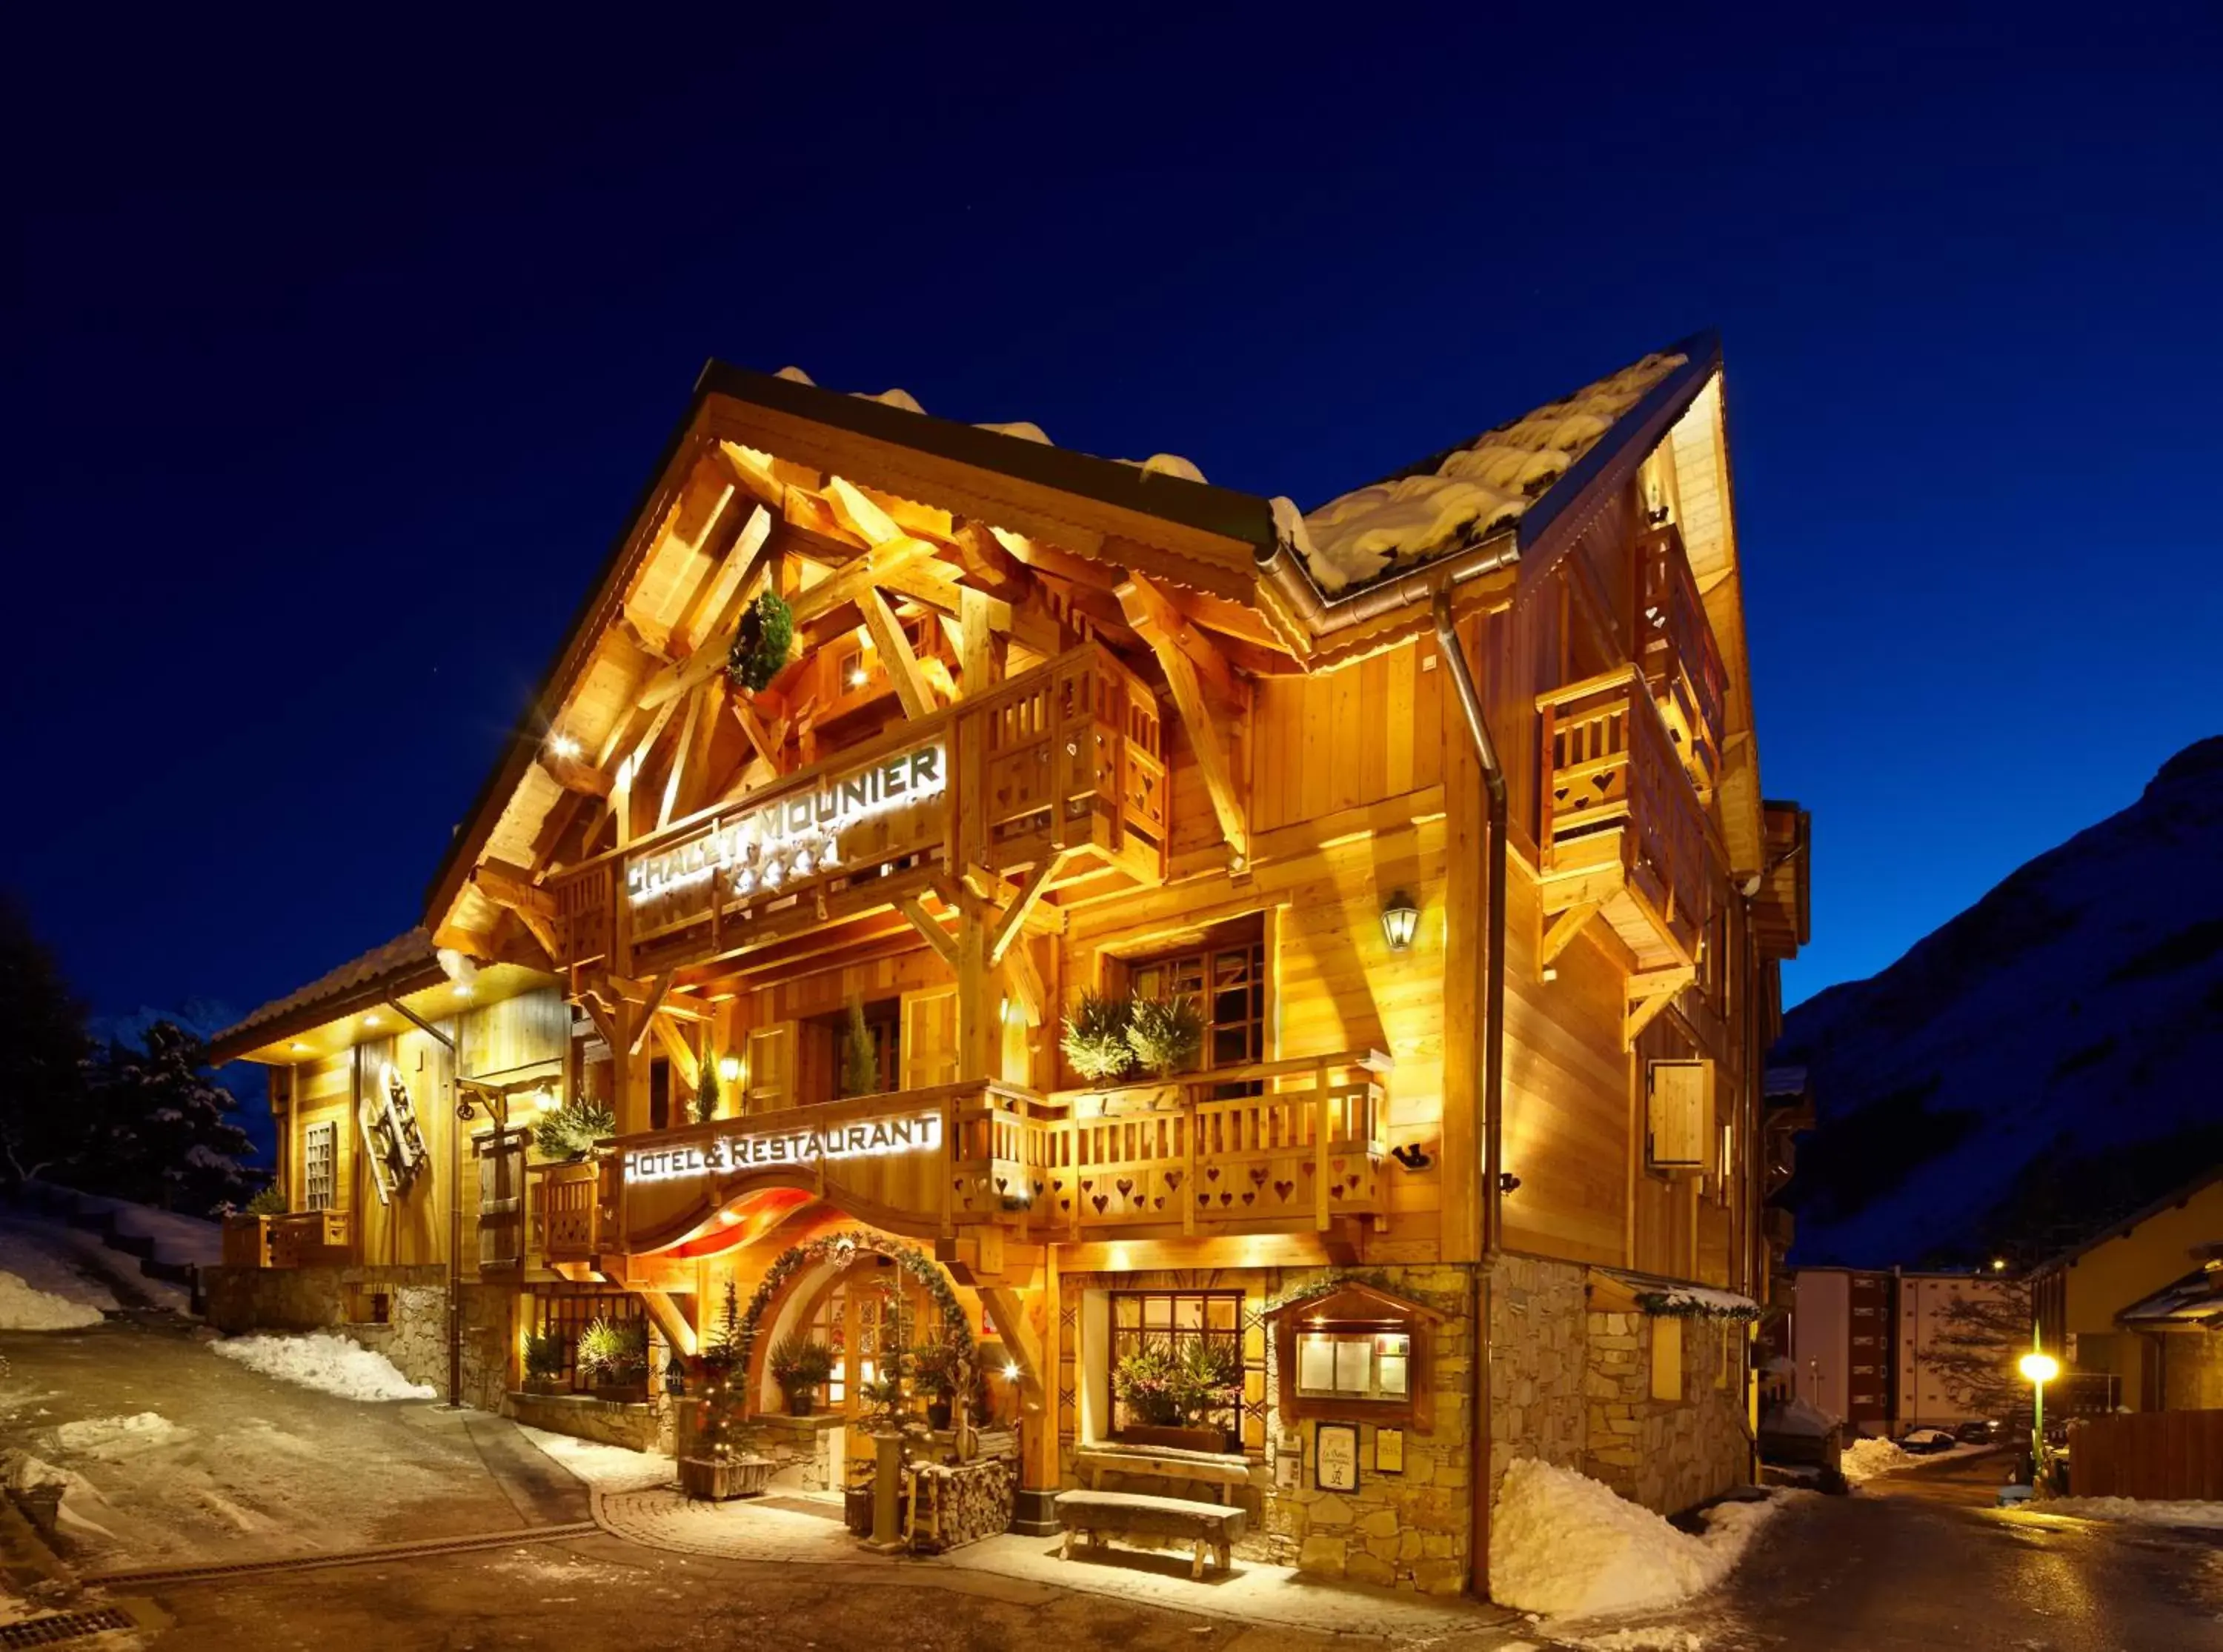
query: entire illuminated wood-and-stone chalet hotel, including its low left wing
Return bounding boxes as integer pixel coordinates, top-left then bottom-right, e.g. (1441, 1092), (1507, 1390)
(205, 338), (1807, 1590)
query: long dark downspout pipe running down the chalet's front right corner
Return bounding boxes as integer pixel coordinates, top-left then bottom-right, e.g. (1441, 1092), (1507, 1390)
(1434, 587), (1507, 1599)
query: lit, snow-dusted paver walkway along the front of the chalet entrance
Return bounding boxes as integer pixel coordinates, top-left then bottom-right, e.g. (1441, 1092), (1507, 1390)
(594, 1485), (1523, 1645)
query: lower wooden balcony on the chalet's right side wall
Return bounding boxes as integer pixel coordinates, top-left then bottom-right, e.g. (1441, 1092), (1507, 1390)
(1536, 665), (1721, 1027)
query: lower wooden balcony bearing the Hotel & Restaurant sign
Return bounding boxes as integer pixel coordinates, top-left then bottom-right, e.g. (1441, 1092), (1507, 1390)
(542, 1050), (1389, 1274)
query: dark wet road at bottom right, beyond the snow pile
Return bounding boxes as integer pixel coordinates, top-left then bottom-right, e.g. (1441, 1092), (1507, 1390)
(1636, 1456), (2223, 1652)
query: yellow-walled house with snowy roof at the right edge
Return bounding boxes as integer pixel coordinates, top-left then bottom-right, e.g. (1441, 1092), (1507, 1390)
(2032, 1165), (2223, 1412)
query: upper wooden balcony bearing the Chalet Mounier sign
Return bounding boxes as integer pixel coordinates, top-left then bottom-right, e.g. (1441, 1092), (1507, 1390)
(547, 645), (1169, 976)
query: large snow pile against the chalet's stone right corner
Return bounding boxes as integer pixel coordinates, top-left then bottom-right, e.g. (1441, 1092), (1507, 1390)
(1489, 1456), (1781, 1616)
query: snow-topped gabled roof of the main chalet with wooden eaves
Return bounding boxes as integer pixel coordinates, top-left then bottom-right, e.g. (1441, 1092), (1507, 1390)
(427, 333), (1743, 934)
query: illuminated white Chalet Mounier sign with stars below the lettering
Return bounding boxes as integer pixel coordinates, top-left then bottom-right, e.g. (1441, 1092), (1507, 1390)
(625, 740), (949, 905)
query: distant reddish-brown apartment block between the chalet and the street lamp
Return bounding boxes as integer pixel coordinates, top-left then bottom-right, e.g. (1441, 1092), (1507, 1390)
(1790, 1268), (2014, 1436)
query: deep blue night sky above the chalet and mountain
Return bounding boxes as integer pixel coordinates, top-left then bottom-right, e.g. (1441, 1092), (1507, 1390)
(0, 7), (2223, 1027)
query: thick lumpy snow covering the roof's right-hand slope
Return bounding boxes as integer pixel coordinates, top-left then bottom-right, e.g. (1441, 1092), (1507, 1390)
(1298, 353), (1687, 593)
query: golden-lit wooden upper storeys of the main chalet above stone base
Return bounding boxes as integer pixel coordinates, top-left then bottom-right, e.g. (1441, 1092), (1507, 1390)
(209, 340), (1805, 1588)
